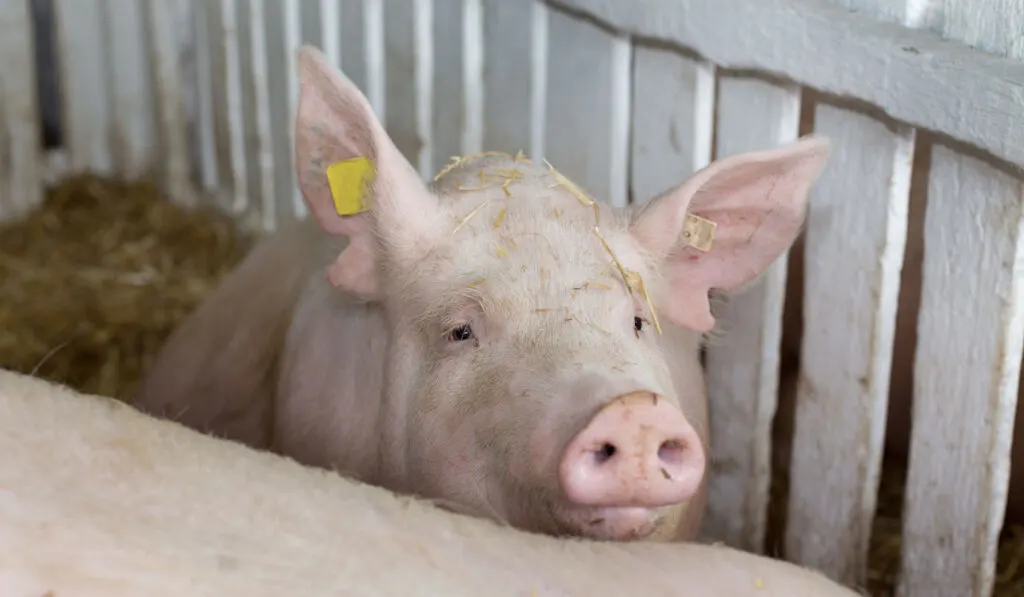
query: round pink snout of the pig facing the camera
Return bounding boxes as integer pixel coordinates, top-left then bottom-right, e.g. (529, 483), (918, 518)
(559, 392), (705, 508)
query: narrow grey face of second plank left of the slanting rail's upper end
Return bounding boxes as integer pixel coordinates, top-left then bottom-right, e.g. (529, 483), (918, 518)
(428, 0), (466, 176)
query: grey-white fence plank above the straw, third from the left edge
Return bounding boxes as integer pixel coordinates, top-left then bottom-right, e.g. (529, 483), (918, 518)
(102, 0), (158, 179)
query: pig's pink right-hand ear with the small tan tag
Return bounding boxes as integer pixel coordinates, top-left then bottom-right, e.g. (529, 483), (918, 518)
(631, 136), (831, 332)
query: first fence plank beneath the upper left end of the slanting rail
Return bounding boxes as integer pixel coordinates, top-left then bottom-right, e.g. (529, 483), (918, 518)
(544, 5), (632, 206)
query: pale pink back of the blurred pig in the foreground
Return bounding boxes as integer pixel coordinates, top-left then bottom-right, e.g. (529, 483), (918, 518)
(0, 371), (856, 597)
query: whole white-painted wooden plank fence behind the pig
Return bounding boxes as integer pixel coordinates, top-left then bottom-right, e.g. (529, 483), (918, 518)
(0, 0), (1024, 597)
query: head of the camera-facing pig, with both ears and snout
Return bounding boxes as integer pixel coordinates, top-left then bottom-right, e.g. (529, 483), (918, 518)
(296, 48), (828, 540)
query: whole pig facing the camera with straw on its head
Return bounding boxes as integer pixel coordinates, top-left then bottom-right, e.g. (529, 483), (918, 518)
(136, 46), (830, 541)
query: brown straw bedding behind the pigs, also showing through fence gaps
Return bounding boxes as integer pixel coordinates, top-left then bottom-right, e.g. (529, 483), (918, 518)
(0, 175), (1024, 597)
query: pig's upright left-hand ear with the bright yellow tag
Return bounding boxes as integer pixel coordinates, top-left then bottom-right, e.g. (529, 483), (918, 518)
(295, 46), (439, 299)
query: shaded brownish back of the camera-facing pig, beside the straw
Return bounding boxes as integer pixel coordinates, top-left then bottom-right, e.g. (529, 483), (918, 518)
(135, 220), (323, 447)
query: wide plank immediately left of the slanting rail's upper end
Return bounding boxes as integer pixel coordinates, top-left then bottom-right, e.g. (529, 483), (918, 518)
(482, 0), (548, 161)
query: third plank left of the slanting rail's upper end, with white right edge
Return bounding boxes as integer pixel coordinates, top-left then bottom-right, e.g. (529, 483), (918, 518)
(384, 0), (433, 176)
